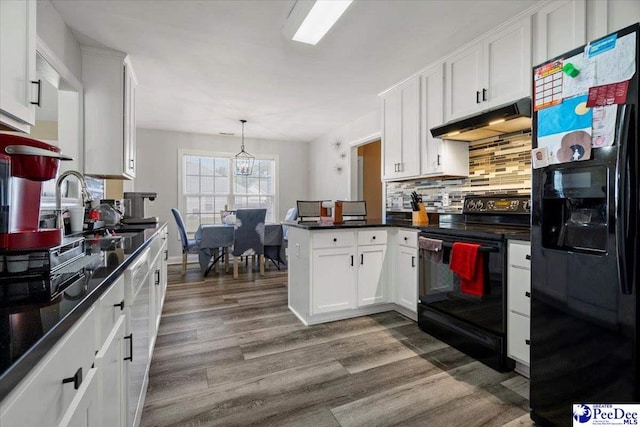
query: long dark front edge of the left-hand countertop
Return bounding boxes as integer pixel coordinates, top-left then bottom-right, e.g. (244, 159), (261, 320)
(0, 222), (166, 401)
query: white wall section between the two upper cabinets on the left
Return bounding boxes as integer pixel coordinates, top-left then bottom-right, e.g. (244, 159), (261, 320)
(36, 0), (82, 81)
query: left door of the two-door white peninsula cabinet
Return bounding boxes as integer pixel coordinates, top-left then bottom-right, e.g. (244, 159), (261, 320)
(311, 247), (357, 315)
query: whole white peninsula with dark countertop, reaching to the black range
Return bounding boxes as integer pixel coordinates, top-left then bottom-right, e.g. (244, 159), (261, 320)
(288, 221), (419, 325)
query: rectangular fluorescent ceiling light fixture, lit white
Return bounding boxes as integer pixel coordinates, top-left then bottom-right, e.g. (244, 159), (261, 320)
(282, 0), (353, 45)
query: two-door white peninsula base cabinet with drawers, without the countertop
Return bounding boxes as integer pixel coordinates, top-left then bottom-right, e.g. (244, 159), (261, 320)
(289, 227), (390, 324)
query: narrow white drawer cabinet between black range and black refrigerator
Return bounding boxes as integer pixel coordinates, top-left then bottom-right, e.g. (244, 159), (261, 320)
(507, 240), (531, 376)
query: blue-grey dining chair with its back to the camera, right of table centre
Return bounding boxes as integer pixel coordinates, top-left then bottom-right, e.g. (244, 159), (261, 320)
(231, 209), (267, 279)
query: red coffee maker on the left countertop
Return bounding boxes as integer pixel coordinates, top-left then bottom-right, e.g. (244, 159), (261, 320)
(0, 134), (72, 251)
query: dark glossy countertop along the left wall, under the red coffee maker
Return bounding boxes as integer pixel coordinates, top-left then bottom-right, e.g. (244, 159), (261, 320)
(0, 223), (165, 404)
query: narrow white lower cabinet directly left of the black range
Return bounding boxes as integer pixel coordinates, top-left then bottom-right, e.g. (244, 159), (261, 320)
(394, 230), (418, 318)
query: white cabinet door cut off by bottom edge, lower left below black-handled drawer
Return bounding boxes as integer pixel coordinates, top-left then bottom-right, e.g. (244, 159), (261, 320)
(57, 368), (102, 427)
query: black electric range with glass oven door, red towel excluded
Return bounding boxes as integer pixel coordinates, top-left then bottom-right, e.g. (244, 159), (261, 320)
(418, 195), (531, 371)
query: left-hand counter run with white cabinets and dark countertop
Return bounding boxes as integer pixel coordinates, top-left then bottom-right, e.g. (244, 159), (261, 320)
(0, 223), (167, 427)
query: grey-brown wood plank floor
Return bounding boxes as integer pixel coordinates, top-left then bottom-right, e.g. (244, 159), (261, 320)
(141, 266), (532, 427)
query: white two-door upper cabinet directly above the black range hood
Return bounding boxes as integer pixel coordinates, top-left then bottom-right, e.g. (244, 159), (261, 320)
(445, 17), (531, 121)
